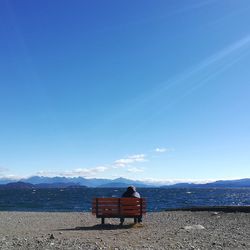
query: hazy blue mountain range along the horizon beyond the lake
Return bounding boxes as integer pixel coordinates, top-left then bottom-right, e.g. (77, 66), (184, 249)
(0, 176), (250, 188)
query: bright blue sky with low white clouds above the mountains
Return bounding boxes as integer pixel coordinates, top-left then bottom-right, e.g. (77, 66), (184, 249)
(0, 0), (250, 184)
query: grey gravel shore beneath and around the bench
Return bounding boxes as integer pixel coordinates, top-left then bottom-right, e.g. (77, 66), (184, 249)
(0, 211), (250, 250)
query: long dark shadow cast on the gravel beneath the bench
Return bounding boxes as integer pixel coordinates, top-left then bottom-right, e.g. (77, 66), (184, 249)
(56, 224), (135, 231)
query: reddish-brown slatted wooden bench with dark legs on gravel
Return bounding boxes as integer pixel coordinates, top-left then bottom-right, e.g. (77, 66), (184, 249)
(92, 198), (146, 224)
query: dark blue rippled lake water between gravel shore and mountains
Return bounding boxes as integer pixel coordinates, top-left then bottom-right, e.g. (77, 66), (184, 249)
(0, 188), (250, 211)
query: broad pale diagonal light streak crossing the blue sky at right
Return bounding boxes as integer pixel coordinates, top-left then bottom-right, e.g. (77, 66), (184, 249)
(121, 35), (250, 125)
